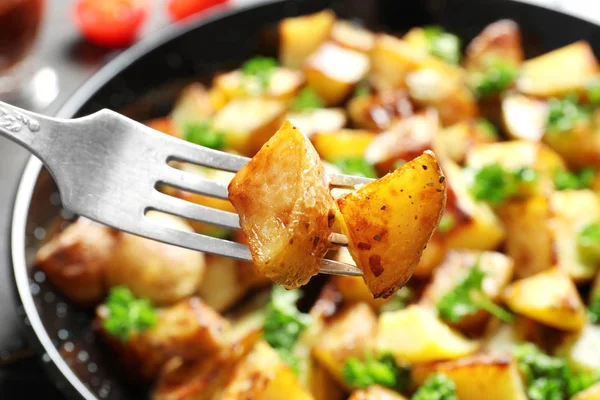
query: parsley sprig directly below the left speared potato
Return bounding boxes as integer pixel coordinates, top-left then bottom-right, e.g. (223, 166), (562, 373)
(263, 285), (310, 372)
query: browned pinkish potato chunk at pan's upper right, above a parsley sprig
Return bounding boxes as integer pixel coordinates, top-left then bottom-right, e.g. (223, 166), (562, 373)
(465, 19), (524, 69)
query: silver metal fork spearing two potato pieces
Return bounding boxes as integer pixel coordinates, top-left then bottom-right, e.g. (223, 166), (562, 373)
(0, 102), (371, 276)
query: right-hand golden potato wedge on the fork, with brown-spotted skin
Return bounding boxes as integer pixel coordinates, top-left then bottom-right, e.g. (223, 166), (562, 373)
(336, 152), (446, 298)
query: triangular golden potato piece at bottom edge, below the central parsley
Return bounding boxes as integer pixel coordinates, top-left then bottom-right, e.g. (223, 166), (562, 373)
(219, 341), (312, 400)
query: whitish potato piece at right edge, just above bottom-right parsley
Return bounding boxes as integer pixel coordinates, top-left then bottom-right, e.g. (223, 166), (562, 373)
(555, 324), (600, 372)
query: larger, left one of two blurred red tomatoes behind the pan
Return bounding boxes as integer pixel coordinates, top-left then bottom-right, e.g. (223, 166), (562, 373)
(73, 0), (150, 48)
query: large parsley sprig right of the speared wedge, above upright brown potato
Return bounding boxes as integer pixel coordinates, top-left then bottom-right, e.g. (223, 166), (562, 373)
(471, 163), (537, 205)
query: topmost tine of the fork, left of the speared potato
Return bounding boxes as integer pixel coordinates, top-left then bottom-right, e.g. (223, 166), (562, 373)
(165, 137), (250, 172)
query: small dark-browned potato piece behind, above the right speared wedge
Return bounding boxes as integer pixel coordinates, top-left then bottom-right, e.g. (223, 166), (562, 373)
(347, 89), (414, 131)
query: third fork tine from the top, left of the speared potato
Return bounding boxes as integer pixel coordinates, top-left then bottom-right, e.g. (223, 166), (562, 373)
(150, 191), (240, 229)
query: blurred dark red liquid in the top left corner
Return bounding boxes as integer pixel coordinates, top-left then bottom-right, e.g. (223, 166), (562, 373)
(0, 0), (44, 71)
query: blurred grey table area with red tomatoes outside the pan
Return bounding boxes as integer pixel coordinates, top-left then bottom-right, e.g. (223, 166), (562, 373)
(0, 0), (600, 400)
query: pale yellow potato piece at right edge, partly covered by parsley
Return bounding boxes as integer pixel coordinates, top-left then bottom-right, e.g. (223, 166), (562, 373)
(547, 189), (600, 282)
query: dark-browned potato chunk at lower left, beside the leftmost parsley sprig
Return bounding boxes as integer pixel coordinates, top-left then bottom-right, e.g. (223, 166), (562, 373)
(97, 297), (227, 379)
